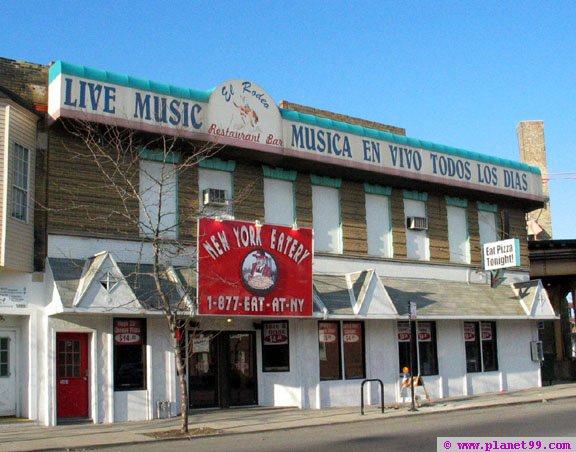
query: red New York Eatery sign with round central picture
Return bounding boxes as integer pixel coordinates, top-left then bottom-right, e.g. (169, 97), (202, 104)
(198, 218), (312, 317)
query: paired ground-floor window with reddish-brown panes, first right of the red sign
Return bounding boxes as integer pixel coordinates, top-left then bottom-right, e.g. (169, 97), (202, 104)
(318, 322), (366, 380)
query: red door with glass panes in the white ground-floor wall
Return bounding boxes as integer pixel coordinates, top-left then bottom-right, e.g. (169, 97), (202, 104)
(56, 333), (88, 420)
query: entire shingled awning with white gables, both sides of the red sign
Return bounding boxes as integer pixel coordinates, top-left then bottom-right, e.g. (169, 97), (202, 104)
(48, 252), (557, 320)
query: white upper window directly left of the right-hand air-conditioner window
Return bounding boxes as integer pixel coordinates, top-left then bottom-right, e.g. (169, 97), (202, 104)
(364, 184), (394, 257)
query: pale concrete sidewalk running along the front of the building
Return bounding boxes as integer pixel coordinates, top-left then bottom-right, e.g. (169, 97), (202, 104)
(0, 383), (576, 451)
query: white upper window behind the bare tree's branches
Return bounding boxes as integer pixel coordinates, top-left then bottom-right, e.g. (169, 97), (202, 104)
(139, 149), (180, 238)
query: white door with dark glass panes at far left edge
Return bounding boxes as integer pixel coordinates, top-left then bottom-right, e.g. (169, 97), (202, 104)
(0, 331), (18, 416)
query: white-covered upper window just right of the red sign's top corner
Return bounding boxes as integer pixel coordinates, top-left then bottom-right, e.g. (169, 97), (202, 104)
(310, 175), (343, 254)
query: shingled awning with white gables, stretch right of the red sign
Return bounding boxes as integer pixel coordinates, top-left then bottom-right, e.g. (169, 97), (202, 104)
(314, 270), (556, 320)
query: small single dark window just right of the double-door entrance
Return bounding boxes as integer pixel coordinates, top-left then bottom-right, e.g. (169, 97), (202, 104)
(262, 321), (290, 372)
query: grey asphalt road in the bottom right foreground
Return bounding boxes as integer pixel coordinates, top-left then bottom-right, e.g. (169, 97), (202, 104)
(109, 399), (576, 452)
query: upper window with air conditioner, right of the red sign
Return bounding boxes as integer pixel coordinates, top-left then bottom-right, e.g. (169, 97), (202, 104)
(404, 190), (430, 261)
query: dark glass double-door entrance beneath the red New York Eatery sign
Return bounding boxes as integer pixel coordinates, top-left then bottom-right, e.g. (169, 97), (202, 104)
(188, 331), (258, 408)
